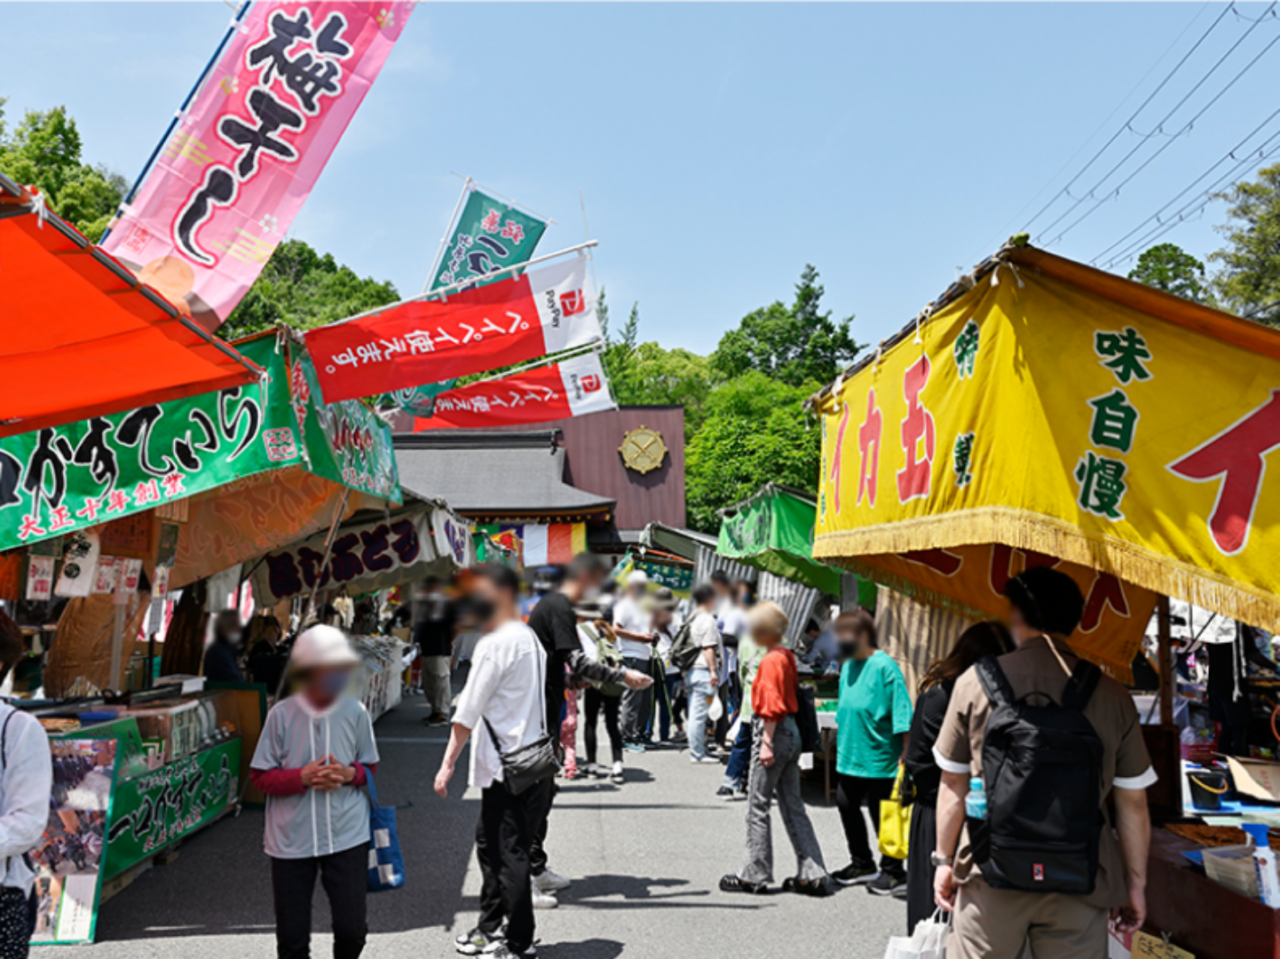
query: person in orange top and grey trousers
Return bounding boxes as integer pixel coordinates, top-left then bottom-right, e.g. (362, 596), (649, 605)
(719, 602), (832, 896)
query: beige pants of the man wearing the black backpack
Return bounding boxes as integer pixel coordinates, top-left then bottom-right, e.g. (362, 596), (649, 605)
(947, 877), (1107, 959)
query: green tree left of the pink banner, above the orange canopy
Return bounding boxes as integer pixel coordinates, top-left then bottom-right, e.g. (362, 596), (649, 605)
(0, 101), (128, 243)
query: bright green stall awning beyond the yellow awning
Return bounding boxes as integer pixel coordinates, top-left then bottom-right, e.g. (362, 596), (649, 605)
(716, 483), (841, 597)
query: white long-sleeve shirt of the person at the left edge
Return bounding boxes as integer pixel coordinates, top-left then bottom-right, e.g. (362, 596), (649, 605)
(0, 703), (54, 894)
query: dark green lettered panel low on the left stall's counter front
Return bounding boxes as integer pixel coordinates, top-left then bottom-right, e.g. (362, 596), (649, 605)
(102, 739), (241, 878)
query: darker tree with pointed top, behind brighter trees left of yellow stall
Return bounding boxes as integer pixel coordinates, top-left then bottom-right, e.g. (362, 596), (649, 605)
(712, 265), (863, 385)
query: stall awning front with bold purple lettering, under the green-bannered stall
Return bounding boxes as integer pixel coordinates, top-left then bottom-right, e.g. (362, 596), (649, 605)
(253, 510), (436, 604)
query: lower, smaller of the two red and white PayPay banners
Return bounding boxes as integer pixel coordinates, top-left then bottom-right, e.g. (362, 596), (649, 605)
(413, 353), (614, 433)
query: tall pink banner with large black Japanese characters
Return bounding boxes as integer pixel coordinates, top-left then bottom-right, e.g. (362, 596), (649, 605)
(102, 0), (413, 330)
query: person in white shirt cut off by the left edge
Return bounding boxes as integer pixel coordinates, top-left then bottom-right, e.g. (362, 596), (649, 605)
(0, 612), (54, 959)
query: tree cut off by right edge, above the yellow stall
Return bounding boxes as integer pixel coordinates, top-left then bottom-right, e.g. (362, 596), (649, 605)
(1210, 164), (1280, 324)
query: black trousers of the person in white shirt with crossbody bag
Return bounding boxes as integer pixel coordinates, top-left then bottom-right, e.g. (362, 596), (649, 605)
(476, 782), (534, 955)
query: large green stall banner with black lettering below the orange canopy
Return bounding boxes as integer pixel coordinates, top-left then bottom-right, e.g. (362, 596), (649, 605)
(0, 335), (399, 551)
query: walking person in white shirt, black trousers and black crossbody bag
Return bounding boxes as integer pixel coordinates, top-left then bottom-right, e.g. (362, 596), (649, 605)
(435, 565), (547, 959)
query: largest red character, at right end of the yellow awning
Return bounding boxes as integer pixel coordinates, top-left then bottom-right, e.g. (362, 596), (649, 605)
(1169, 389), (1280, 556)
